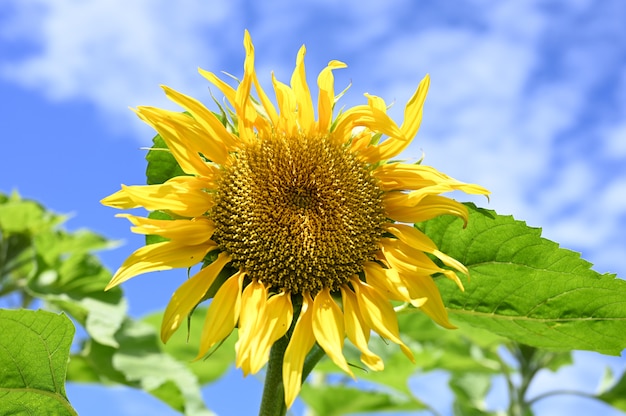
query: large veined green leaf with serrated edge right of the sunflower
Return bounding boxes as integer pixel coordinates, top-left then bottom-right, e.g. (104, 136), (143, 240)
(421, 204), (626, 355)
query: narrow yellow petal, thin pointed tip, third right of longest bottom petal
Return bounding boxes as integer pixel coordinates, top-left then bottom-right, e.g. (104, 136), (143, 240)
(350, 278), (415, 362)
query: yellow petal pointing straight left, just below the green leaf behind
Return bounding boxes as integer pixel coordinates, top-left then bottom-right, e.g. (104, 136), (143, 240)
(100, 176), (213, 217)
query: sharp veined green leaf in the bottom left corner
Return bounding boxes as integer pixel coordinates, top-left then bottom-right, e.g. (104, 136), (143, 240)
(0, 310), (76, 415)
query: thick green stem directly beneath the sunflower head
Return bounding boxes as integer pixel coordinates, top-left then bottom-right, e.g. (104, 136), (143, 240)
(259, 336), (289, 416)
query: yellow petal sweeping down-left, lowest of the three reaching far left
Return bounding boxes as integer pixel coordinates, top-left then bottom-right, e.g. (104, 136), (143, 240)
(105, 241), (217, 290)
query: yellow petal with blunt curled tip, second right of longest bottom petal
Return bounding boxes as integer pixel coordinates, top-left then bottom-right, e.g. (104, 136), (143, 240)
(340, 287), (385, 371)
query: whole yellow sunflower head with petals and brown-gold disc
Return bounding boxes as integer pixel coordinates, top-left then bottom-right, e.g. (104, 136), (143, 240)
(102, 31), (488, 407)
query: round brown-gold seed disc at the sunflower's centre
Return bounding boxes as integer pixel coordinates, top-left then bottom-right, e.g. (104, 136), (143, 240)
(209, 135), (386, 293)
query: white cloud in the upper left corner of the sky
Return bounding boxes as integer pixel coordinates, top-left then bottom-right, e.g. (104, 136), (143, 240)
(2, 0), (242, 139)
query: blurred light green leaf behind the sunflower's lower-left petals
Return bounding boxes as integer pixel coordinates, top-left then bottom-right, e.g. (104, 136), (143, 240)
(143, 308), (237, 384)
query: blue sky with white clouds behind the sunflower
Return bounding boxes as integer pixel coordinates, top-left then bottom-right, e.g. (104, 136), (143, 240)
(0, 0), (626, 415)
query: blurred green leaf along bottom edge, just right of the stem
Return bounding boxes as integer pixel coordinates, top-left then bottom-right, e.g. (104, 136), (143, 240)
(301, 384), (426, 416)
